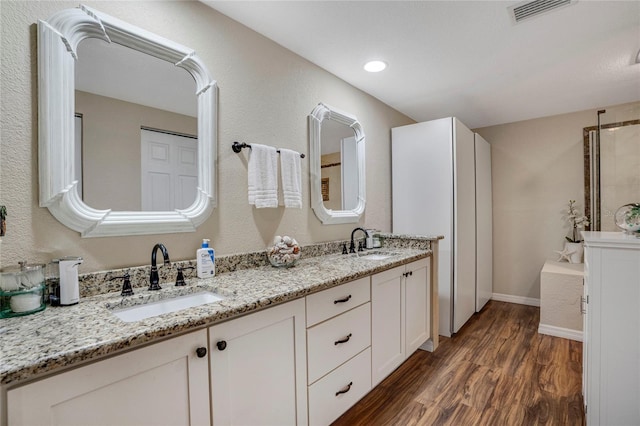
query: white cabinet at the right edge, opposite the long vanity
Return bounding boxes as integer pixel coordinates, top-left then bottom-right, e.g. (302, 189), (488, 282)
(583, 232), (640, 425)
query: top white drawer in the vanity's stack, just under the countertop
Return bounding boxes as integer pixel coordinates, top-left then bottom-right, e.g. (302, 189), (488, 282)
(306, 277), (371, 327)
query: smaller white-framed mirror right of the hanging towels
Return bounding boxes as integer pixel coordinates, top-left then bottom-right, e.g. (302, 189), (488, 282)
(309, 103), (366, 224)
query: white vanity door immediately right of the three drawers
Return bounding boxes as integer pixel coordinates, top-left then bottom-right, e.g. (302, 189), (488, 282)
(371, 266), (405, 386)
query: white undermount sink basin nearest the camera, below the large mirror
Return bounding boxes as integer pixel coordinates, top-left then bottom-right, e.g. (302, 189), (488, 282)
(111, 291), (224, 322)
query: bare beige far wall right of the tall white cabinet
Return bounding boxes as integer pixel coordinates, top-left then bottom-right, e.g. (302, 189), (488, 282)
(475, 103), (640, 299)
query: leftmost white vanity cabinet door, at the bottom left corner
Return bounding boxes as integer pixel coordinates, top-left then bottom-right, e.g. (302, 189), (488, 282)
(7, 330), (211, 426)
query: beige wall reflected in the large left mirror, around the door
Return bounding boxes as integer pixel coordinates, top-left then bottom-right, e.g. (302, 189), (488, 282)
(76, 89), (198, 210)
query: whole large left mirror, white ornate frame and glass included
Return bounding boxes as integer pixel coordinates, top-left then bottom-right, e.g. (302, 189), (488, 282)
(38, 5), (217, 237)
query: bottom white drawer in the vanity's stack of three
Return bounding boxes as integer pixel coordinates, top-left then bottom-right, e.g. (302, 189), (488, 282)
(309, 348), (371, 425)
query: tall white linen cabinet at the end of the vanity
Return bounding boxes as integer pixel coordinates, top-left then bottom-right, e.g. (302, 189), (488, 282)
(391, 117), (493, 337)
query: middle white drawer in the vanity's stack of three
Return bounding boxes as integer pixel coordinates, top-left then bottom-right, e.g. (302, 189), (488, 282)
(307, 303), (371, 384)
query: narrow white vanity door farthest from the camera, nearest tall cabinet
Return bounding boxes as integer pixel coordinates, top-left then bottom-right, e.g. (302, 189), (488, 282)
(405, 259), (431, 358)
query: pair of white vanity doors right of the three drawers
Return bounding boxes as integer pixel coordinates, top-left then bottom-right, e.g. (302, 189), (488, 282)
(371, 259), (431, 386)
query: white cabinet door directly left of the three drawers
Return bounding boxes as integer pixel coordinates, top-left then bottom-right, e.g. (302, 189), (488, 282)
(209, 299), (307, 426)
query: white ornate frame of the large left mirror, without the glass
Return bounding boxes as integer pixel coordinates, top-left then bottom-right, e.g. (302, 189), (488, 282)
(38, 5), (217, 237)
